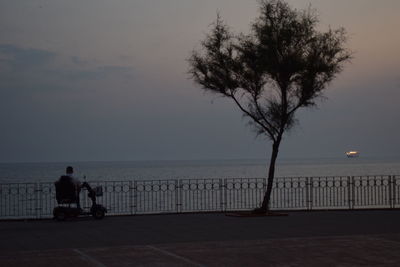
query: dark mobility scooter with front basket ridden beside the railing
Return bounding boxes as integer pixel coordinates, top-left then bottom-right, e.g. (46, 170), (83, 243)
(53, 176), (107, 221)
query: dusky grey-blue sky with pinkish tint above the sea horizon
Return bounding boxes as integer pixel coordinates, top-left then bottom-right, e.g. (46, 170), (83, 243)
(0, 0), (400, 162)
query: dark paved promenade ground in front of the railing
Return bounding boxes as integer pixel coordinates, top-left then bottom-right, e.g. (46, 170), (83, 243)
(0, 210), (400, 267)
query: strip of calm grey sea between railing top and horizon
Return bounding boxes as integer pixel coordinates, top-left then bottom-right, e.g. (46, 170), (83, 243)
(0, 157), (400, 183)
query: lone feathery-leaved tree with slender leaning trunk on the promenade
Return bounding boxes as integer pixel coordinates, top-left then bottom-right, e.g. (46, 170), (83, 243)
(188, 0), (351, 212)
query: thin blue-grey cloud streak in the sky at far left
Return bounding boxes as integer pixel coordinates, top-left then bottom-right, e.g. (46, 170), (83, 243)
(0, 44), (134, 92)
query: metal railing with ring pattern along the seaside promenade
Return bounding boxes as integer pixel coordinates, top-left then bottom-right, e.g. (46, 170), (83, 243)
(0, 175), (400, 219)
